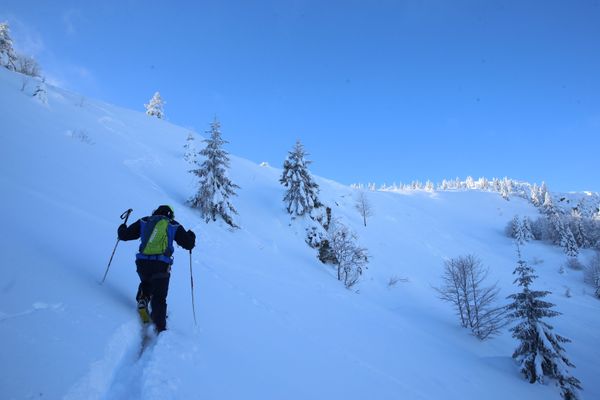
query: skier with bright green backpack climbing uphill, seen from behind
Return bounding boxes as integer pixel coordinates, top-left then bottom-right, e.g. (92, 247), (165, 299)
(118, 205), (196, 333)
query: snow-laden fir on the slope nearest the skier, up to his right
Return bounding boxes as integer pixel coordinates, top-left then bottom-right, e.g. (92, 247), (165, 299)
(189, 119), (239, 228)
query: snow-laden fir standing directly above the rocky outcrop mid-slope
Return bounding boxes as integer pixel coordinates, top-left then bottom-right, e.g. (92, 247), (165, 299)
(279, 140), (321, 216)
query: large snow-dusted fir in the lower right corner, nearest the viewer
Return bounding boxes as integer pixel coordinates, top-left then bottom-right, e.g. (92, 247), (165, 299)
(508, 246), (581, 400)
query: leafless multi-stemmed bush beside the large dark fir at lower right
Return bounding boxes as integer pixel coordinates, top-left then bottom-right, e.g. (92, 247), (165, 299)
(435, 255), (506, 340)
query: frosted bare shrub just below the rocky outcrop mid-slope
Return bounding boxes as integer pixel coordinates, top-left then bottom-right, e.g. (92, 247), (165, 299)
(327, 220), (369, 288)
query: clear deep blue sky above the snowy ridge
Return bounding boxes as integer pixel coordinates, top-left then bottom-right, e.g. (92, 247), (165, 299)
(0, 0), (600, 191)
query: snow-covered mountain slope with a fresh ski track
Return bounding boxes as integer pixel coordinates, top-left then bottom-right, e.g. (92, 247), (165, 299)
(0, 69), (600, 400)
